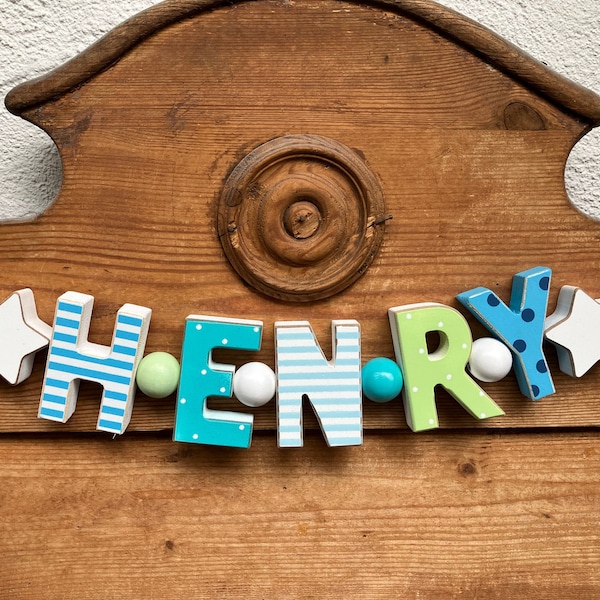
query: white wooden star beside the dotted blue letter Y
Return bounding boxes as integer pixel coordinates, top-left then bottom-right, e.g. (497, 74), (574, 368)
(544, 285), (600, 377)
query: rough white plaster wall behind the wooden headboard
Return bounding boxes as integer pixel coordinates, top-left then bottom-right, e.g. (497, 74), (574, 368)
(0, 0), (600, 220)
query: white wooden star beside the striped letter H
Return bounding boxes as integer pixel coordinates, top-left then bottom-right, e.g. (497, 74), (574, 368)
(0, 289), (52, 385)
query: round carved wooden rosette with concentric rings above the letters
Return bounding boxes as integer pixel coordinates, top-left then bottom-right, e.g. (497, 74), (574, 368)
(217, 135), (384, 302)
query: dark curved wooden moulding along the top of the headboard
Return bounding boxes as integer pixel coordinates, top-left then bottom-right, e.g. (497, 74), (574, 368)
(5, 0), (600, 125)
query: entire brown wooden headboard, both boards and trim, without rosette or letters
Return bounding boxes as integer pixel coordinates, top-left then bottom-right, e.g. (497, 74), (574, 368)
(0, 0), (600, 600)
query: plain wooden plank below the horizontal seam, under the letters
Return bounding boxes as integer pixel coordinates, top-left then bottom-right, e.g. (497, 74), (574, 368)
(0, 432), (600, 600)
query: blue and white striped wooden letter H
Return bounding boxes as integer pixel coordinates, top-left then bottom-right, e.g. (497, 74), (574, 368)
(38, 292), (152, 434)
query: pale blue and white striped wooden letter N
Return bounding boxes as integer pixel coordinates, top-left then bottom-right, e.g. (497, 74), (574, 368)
(275, 320), (362, 448)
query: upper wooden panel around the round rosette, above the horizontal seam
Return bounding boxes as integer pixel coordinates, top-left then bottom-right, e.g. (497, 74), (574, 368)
(0, 0), (600, 432)
